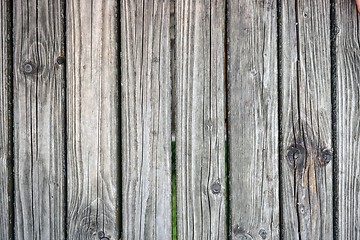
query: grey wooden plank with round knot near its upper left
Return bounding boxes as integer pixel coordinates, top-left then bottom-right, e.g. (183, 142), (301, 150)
(13, 0), (65, 239)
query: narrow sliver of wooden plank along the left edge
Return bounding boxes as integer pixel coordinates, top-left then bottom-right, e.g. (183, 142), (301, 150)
(0, 0), (12, 239)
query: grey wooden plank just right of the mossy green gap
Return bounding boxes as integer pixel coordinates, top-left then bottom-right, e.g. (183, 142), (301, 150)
(175, 0), (226, 239)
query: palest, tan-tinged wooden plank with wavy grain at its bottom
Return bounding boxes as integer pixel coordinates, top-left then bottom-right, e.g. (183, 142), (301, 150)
(66, 0), (120, 239)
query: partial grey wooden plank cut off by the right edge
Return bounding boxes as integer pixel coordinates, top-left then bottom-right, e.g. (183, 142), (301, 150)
(335, 0), (360, 240)
